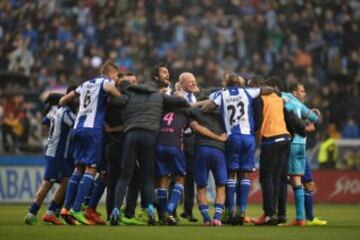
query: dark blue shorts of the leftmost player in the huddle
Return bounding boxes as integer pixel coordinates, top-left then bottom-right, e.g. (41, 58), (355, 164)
(43, 156), (74, 183)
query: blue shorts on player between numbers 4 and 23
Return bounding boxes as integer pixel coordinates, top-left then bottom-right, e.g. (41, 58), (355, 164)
(193, 146), (227, 187)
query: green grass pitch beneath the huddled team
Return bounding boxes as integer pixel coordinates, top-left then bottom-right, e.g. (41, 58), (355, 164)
(0, 204), (360, 240)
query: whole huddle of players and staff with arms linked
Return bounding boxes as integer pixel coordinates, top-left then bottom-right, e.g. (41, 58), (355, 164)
(25, 63), (327, 226)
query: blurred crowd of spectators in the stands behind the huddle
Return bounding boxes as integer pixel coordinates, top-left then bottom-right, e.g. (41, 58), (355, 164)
(0, 0), (360, 167)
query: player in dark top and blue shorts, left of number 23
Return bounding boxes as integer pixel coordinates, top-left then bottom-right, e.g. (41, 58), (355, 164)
(187, 92), (227, 226)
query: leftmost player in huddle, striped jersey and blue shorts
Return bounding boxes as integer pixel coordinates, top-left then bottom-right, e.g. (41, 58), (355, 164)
(25, 87), (75, 225)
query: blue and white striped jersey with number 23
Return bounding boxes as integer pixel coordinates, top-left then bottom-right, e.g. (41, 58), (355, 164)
(212, 87), (260, 135)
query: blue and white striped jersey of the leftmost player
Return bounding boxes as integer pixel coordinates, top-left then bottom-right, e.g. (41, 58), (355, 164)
(43, 106), (76, 158)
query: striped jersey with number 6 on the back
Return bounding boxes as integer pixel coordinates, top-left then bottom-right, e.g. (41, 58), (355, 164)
(74, 76), (115, 129)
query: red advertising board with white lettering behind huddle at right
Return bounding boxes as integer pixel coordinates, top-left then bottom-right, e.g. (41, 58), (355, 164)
(249, 170), (360, 203)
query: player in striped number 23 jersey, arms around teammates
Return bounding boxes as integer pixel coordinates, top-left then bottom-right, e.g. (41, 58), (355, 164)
(203, 74), (274, 225)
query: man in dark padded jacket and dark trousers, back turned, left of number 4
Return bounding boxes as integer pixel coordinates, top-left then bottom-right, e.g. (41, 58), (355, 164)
(110, 81), (189, 225)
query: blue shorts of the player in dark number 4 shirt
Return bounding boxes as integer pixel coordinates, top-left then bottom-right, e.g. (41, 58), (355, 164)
(155, 144), (186, 177)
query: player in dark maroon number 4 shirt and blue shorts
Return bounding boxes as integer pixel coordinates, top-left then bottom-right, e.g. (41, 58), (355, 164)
(155, 112), (190, 225)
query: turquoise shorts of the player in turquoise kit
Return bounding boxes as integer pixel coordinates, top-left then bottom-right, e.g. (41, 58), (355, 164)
(289, 143), (306, 175)
